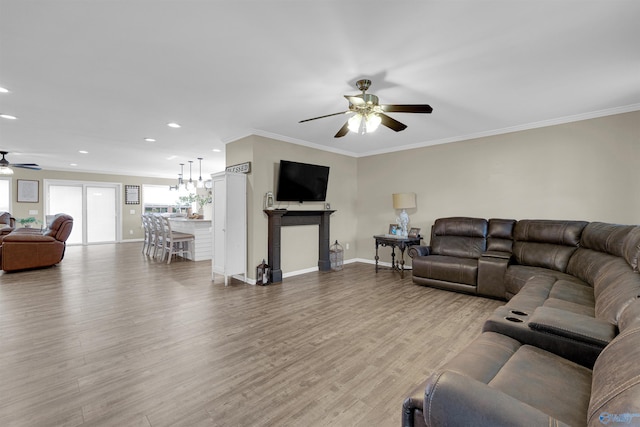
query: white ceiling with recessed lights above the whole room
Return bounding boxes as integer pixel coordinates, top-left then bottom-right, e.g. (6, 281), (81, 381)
(0, 0), (640, 178)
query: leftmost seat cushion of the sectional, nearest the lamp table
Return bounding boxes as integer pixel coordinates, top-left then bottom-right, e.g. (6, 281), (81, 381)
(413, 255), (478, 286)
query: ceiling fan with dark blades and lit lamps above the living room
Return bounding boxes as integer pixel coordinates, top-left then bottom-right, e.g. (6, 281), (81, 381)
(299, 79), (433, 138)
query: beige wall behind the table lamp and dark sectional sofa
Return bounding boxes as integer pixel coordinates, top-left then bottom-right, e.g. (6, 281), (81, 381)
(357, 112), (640, 261)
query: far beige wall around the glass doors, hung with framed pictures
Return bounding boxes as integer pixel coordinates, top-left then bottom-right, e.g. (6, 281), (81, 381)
(5, 168), (175, 240)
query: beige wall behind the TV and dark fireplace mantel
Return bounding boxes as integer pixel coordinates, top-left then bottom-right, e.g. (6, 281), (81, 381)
(228, 136), (358, 279)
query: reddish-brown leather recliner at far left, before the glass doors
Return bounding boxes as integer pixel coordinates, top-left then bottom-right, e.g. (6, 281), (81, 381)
(0, 214), (73, 271)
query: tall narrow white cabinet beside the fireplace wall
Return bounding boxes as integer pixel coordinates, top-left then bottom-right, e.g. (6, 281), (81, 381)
(211, 172), (247, 286)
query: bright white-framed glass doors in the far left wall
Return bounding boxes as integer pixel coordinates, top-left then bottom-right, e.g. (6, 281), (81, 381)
(45, 181), (122, 245)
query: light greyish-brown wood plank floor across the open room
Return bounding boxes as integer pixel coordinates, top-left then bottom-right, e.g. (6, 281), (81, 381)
(0, 243), (502, 427)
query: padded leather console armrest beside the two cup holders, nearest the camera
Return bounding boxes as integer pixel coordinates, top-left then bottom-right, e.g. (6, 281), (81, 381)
(529, 306), (616, 348)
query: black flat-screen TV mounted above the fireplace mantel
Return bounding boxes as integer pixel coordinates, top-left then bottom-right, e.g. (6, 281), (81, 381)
(276, 160), (329, 202)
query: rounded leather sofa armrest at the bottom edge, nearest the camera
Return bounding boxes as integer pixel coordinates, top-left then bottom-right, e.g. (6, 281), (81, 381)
(424, 371), (566, 426)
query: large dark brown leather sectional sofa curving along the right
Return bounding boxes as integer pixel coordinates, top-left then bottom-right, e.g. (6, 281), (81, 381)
(403, 217), (640, 426)
